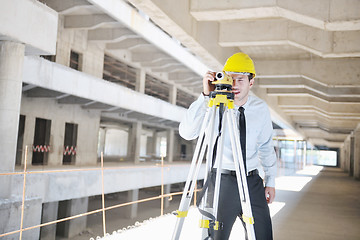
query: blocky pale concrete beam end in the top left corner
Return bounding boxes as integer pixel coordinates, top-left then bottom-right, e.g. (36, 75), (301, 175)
(0, 0), (58, 55)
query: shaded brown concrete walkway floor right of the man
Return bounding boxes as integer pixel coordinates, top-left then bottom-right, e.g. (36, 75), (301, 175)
(273, 168), (360, 240)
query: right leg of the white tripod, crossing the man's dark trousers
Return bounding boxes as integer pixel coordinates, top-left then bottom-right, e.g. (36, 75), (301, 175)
(228, 109), (256, 240)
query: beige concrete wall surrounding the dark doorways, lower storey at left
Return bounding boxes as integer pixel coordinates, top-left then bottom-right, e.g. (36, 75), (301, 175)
(20, 96), (100, 165)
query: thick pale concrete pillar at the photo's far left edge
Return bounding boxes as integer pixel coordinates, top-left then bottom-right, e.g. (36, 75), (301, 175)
(0, 41), (25, 198)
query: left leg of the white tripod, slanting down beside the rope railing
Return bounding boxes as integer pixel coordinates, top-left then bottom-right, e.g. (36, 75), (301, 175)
(172, 107), (215, 240)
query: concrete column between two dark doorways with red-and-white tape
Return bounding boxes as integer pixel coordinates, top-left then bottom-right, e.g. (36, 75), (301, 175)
(48, 118), (65, 166)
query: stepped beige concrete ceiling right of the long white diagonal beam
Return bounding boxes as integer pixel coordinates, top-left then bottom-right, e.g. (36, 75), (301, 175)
(124, 0), (360, 147)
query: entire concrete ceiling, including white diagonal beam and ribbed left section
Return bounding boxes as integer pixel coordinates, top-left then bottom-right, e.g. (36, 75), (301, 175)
(41, 0), (360, 147)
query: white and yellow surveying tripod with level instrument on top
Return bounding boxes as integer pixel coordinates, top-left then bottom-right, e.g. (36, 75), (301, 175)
(172, 72), (255, 240)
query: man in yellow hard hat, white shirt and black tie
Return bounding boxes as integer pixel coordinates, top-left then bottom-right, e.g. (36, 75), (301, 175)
(179, 53), (276, 240)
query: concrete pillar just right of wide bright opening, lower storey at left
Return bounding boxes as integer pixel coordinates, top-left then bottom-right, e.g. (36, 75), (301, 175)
(127, 122), (142, 163)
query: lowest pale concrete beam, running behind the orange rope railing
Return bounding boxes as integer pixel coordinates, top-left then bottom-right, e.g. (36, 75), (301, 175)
(12, 164), (205, 202)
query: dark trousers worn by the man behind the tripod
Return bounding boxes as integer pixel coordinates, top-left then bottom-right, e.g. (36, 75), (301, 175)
(209, 174), (273, 240)
